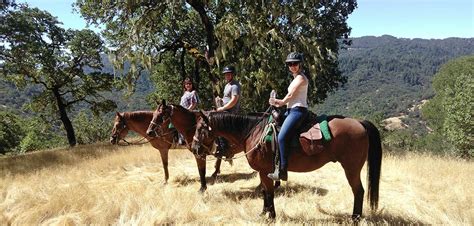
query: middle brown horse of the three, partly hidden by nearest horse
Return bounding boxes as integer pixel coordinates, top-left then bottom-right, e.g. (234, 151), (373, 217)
(146, 100), (239, 192)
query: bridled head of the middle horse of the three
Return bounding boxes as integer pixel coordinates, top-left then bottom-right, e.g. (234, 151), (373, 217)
(146, 100), (173, 137)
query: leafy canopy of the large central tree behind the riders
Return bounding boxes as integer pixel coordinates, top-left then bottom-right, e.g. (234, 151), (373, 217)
(76, 0), (357, 111)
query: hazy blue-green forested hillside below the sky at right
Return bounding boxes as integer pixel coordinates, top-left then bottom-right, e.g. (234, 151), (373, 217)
(316, 35), (474, 117)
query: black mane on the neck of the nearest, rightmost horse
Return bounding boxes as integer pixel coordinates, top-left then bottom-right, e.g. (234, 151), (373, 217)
(209, 112), (265, 135)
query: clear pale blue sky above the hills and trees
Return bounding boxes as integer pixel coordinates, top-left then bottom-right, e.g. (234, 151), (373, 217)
(17, 0), (474, 39)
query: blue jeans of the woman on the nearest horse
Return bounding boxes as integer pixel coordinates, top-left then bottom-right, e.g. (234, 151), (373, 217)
(278, 107), (308, 169)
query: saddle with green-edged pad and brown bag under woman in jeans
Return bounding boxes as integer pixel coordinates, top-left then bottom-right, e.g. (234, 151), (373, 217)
(266, 108), (331, 155)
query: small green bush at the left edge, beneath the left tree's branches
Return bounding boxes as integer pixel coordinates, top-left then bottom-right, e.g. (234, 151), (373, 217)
(0, 111), (25, 154)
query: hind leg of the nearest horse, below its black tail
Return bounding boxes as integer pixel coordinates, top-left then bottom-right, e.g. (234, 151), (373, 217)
(344, 168), (364, 220)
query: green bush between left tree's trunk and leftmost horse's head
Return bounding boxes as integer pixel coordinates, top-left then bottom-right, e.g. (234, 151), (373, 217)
(73, 111), (112, 144)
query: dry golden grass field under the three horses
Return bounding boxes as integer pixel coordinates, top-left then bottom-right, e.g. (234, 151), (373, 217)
(0, 144), (474, 225)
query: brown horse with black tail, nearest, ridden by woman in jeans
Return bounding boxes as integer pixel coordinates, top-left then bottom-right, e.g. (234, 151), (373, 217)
(192, 112), (382, 219)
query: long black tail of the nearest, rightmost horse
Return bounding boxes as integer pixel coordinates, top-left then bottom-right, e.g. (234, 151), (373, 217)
(360, 120), (382, 210)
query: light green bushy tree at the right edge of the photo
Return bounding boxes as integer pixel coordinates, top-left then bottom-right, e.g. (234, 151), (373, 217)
(423, 55), (474, 157)
